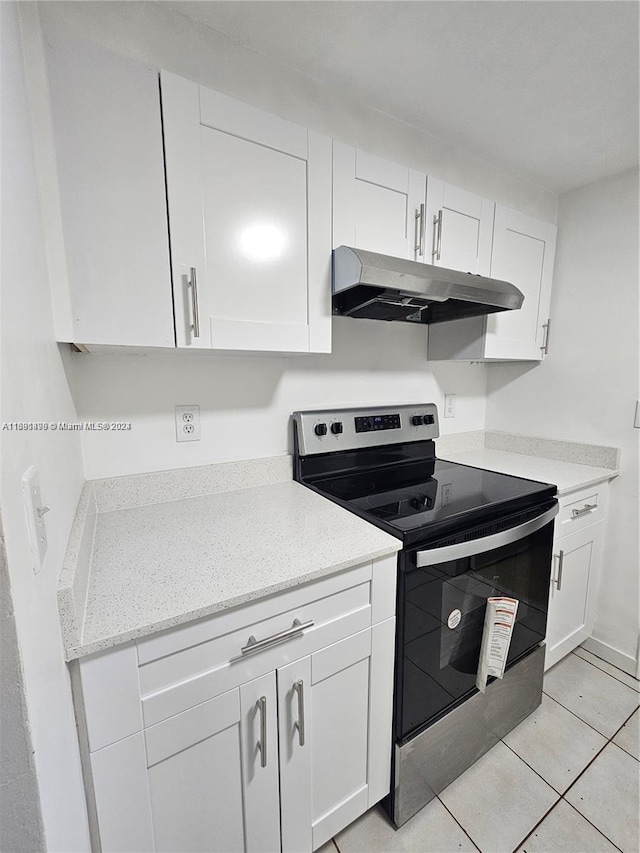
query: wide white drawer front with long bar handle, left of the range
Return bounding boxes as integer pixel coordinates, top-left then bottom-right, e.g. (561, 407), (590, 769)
(139, 580), (371, 726)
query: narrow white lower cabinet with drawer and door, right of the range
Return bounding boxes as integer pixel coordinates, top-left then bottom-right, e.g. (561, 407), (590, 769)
(545, 484), (607, 669)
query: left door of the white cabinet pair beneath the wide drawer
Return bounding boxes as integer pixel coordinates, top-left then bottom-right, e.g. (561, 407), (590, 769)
(145, 673), (280, 853)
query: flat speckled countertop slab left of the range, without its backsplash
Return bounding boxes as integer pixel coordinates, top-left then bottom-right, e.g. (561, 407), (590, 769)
(61, 466), (401, 660)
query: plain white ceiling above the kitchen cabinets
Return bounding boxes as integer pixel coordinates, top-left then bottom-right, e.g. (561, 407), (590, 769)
(174, 0), (639, 193)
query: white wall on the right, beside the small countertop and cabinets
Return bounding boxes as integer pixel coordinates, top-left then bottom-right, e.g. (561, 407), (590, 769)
(487, 172), (640, 658)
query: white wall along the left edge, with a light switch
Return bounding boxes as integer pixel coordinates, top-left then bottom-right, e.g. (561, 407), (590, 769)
(0, 3), (89, 851)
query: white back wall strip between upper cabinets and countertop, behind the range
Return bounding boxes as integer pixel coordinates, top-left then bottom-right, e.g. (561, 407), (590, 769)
(69, 318), (486, 479)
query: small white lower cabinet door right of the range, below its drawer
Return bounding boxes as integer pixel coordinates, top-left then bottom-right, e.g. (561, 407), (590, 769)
(545, 522), (603, 669)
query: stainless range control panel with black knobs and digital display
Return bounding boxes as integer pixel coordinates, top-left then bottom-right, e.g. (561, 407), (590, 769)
(293, 403), (440, 456)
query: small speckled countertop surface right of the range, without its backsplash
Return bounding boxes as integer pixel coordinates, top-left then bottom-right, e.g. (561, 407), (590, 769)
(438, 447), (618, 495)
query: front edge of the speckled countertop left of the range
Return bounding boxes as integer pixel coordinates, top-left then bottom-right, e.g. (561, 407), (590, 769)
(65, 531), (402, 662)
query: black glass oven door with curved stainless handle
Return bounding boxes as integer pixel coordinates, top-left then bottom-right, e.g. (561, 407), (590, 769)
(395, 501), (558, 741)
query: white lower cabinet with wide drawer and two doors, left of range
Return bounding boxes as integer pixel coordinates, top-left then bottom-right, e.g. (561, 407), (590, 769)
(73, 555), (395, 853)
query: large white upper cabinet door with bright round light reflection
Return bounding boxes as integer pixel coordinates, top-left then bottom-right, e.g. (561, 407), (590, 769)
(161, 72), (331, 352)
